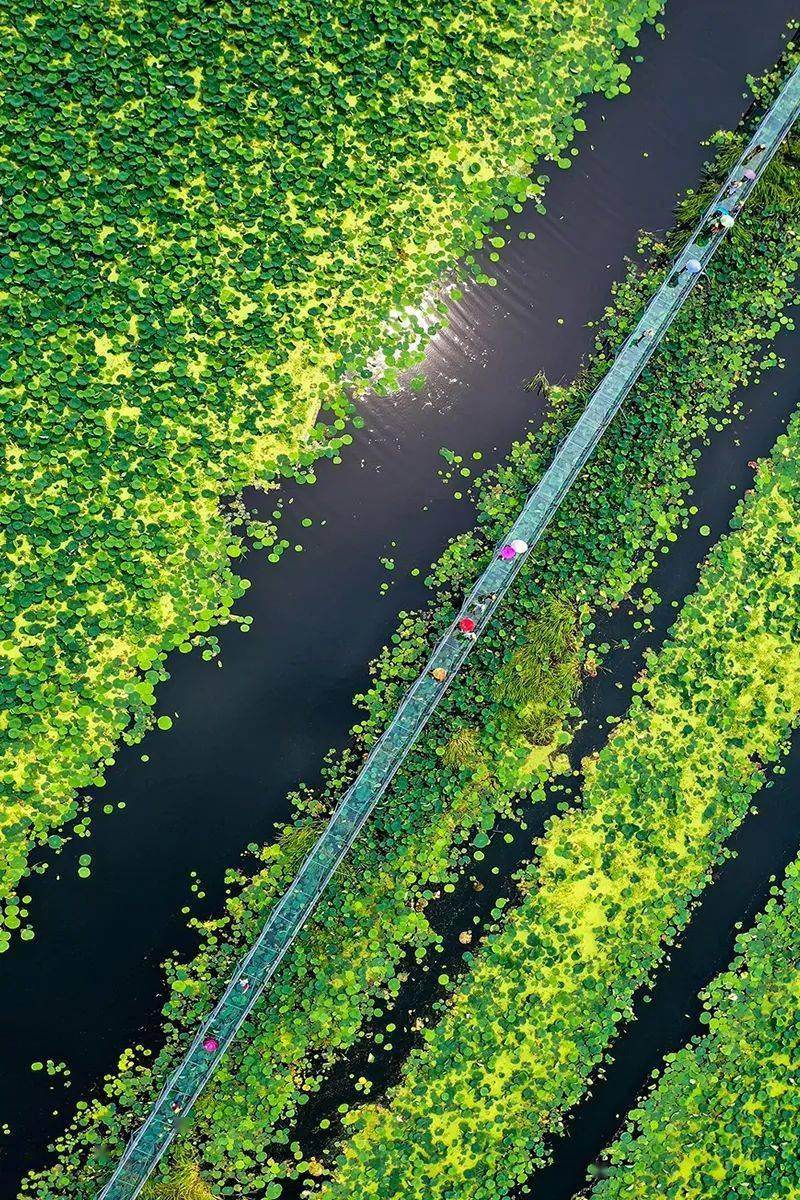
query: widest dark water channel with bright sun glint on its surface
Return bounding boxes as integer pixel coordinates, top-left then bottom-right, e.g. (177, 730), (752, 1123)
(0, 0), (795, 1195)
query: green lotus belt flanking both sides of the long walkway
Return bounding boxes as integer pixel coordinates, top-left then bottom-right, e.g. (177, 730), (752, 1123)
(24, 63), (798, 1200)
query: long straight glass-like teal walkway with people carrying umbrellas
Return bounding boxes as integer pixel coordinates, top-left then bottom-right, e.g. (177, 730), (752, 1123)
(98, 58), (800, 1200)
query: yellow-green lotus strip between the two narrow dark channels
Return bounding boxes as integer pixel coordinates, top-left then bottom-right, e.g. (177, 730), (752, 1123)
(323, 393), (800, 1200)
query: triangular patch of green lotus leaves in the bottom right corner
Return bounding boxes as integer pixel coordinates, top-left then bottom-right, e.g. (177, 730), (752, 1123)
(593, 860), (800, 1200)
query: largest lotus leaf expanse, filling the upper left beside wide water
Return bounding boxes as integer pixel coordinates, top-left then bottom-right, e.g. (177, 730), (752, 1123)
(0, 0), (660, 949)
